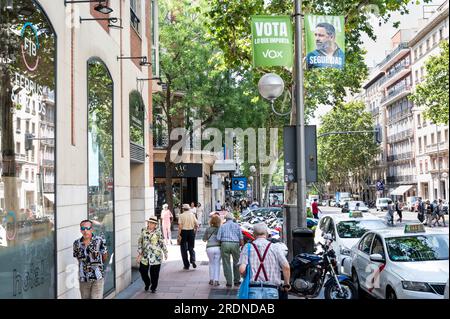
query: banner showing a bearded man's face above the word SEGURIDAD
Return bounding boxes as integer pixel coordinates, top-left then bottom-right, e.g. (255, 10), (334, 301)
(305, 15), (345, 69)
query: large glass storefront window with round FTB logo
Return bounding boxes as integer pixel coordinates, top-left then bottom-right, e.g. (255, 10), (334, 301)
(0, 0), (56, 299)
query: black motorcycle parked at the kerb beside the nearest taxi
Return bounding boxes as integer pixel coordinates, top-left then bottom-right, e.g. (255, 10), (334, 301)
(290, 236), (357, 299)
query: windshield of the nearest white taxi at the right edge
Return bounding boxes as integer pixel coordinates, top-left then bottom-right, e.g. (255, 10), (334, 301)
(386, 234), (448, 262)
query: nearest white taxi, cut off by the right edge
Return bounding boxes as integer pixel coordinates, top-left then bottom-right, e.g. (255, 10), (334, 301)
(351, 224), (449, 299)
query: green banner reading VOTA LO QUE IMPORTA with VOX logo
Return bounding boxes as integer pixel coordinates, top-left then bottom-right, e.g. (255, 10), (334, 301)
(251, 16), (293, 67)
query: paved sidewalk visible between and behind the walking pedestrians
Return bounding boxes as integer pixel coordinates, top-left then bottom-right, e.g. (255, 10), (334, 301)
(115, 227), (238, 299)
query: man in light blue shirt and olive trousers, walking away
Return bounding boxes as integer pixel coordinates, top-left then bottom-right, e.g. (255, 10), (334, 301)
(217, 213), (244, 288)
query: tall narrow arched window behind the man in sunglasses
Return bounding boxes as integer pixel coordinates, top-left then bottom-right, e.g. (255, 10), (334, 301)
(87, 58), (115, 294)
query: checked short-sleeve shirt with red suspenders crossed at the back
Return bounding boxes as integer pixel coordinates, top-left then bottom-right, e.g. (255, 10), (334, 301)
(239, 238), (289, 286)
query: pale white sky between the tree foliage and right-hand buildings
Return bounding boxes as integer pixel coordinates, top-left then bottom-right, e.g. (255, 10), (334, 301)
(309, 0), (444, 125)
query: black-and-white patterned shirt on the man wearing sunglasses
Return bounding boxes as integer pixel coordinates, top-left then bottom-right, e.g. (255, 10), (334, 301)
(73, 236), (108, 282)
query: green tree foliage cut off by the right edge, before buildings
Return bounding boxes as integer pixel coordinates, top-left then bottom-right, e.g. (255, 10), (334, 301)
(411, 41), (449, 124)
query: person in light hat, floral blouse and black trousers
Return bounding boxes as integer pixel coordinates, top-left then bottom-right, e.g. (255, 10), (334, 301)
(136, 216), (167, 293)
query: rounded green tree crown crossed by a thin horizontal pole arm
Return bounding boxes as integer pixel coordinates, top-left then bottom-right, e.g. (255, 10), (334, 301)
(317, 102), (379, 189)
